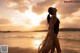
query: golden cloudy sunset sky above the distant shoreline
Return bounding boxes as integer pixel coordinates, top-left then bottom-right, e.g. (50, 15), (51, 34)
(0, 0), (80, 31)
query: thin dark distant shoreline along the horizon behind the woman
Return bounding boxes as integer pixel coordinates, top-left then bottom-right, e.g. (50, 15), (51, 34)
(0, 28), (80, 33)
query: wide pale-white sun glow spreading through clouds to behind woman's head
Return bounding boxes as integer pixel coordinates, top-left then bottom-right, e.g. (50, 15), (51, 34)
(11, 7), (61, 29)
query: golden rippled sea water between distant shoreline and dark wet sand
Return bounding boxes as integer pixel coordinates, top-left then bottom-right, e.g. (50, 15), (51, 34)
(0, 31), (80, 51)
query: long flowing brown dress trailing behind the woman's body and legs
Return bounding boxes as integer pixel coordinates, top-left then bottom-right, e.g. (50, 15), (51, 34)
(38, 16), (57, 53)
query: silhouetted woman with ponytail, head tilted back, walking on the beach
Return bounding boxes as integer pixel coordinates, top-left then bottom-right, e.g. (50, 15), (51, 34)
(39, 7), (61, 53)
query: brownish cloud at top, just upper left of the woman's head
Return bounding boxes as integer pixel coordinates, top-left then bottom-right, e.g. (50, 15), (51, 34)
(32, 0), (57, 14)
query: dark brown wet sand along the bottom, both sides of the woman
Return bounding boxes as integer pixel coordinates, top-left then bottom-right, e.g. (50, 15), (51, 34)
(8, 47), (79, 53)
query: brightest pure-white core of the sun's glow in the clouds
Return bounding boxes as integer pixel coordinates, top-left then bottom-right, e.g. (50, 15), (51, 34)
(22, 6), (42, 26)
